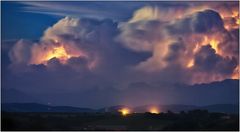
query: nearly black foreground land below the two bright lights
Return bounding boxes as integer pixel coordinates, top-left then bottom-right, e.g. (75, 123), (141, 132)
(1, 110), (239, 130)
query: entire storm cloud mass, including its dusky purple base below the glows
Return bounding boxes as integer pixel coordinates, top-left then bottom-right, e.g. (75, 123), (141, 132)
(5, 3), (239, 108)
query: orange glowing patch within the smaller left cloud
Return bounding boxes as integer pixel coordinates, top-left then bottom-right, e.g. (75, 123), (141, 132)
(29, 39), (99, 70)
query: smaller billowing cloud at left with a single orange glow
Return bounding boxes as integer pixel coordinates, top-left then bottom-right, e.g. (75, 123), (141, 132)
(10, 17), (120, 70)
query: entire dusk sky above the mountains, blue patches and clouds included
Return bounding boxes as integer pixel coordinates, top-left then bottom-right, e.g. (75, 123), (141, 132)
(1, 1), (240, 108)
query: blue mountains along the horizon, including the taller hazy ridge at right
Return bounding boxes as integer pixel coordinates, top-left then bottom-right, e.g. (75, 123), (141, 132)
(1, 79), (239, 113)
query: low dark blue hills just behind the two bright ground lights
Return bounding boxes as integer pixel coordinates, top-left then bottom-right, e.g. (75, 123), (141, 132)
(2, 103), (239, 114)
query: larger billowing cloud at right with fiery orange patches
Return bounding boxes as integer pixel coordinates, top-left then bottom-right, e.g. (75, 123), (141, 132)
(119, 5), (239, 83)
